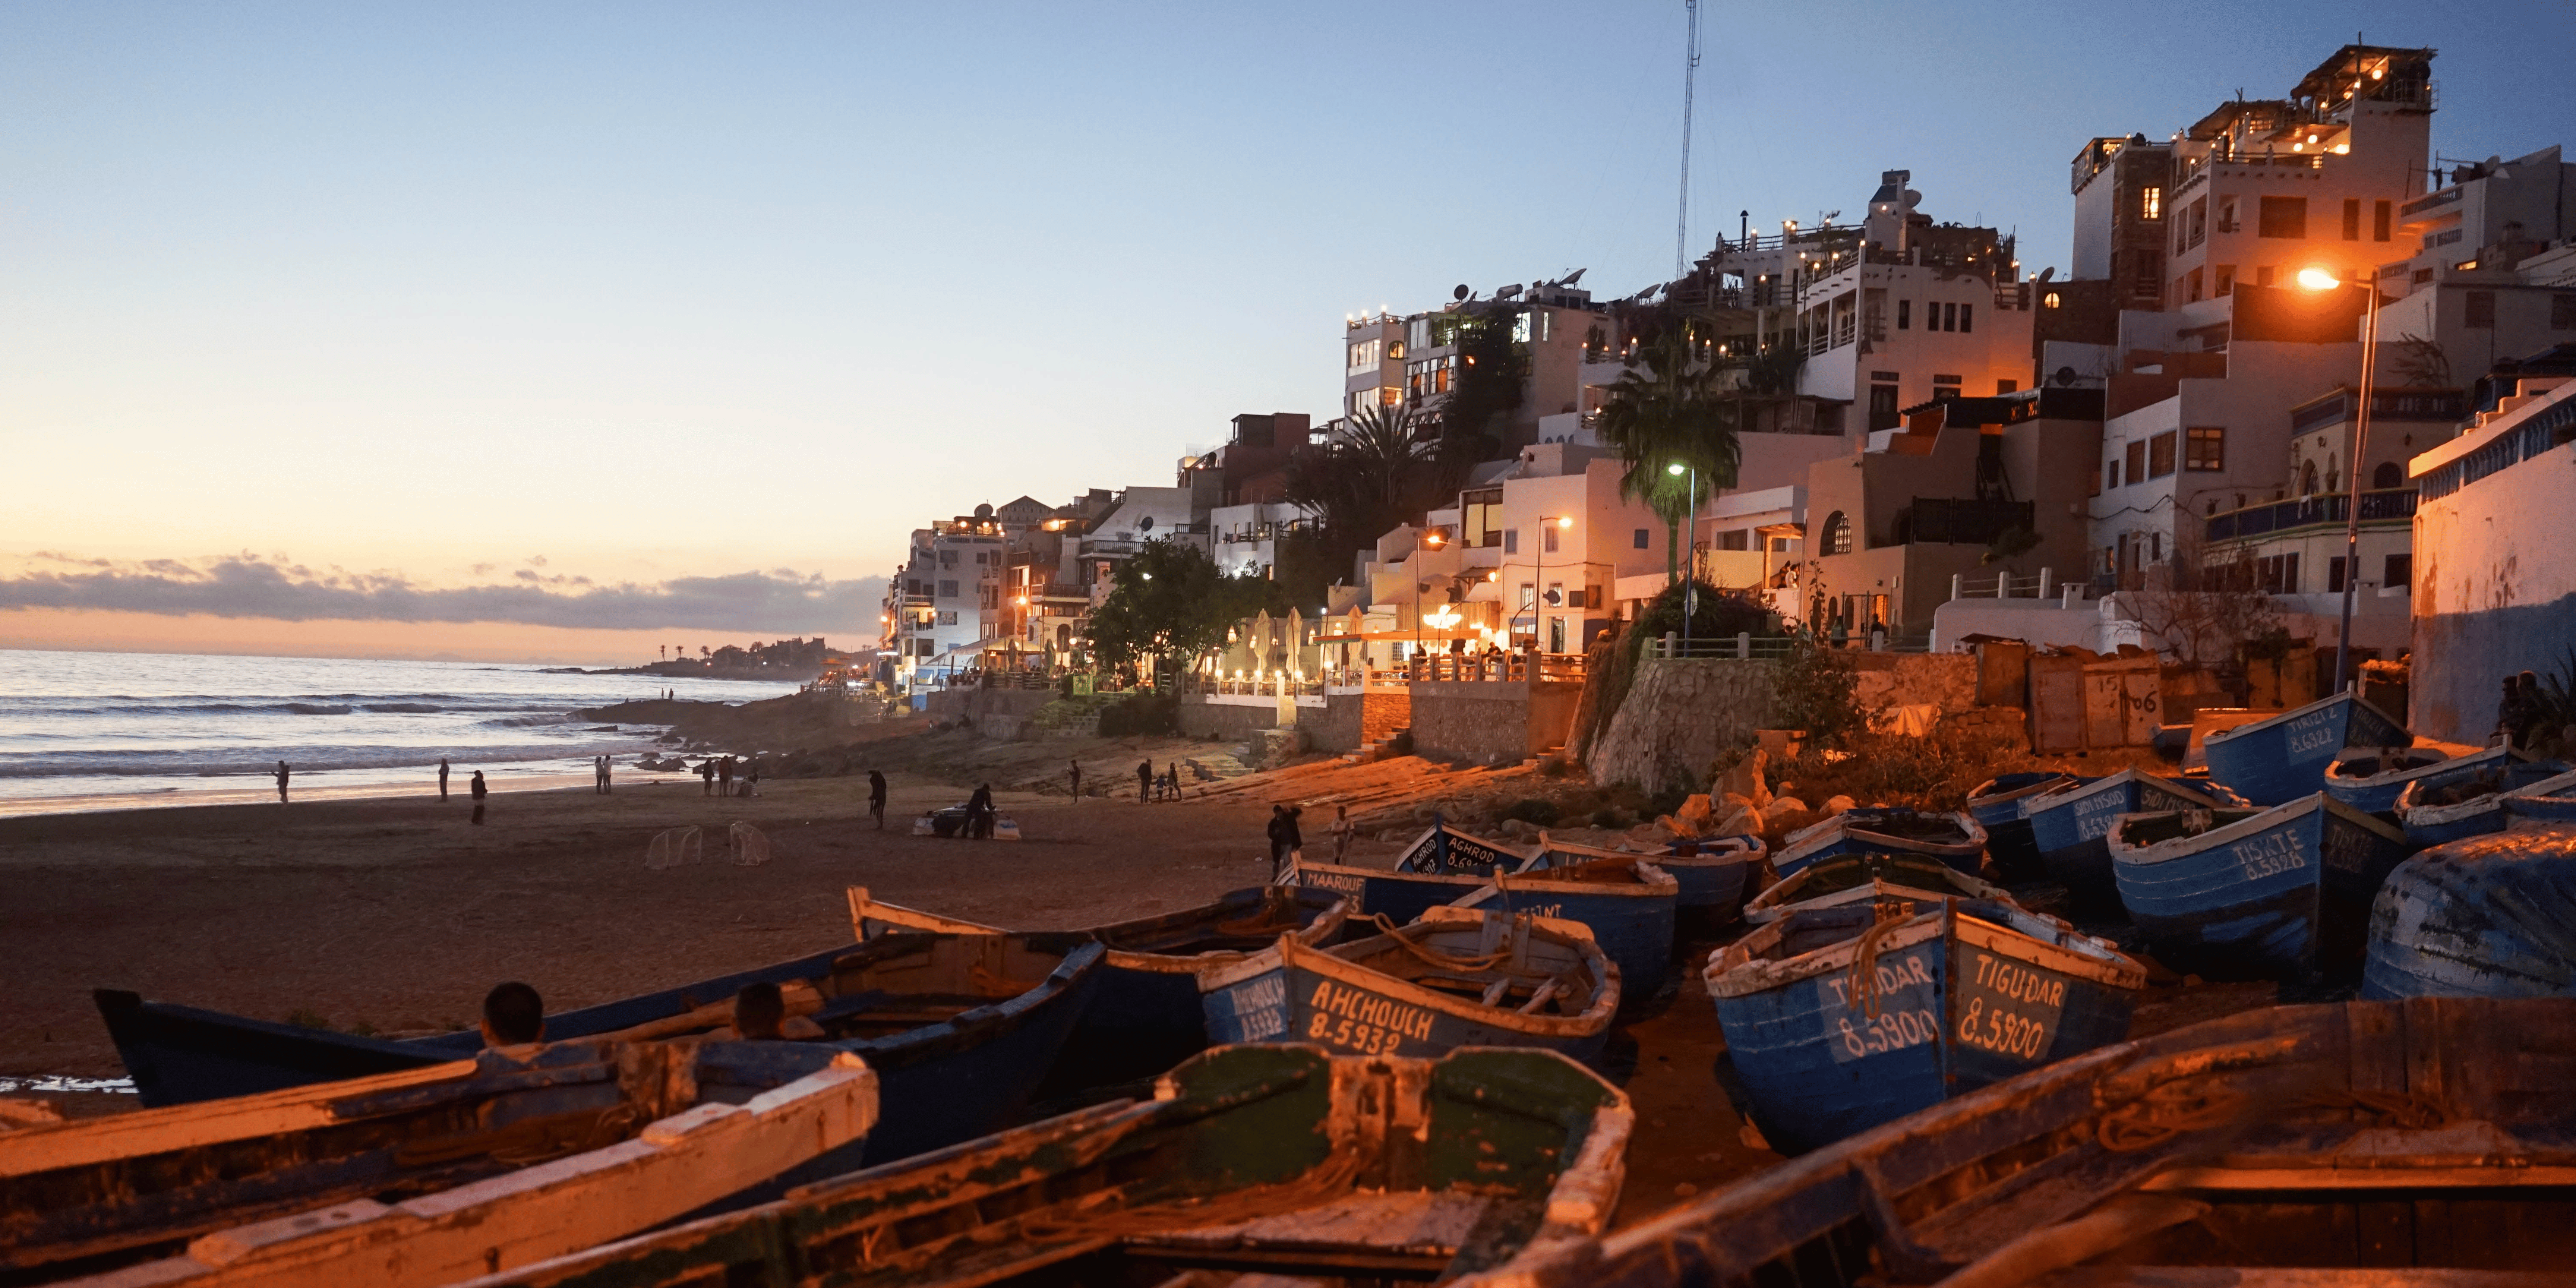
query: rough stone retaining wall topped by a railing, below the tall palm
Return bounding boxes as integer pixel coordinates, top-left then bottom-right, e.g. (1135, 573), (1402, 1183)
(1587, 657), (1772, 791)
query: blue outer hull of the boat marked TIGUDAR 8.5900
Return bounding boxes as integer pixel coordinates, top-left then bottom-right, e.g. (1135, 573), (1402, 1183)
(1711, 917), (2143, 1154)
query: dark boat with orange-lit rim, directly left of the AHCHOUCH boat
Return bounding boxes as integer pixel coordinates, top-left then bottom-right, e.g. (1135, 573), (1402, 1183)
(850, 886), (1350, 1102)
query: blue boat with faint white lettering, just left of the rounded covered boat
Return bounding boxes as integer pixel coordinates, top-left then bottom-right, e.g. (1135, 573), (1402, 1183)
(2110, 791), (2411, 979)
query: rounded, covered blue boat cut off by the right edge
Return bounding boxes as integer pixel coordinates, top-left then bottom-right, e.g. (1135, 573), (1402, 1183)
(2362, 827), (2576, 1000)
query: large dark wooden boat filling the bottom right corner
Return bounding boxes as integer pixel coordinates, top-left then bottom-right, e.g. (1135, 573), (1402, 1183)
(1453, 997), (2576, 1288)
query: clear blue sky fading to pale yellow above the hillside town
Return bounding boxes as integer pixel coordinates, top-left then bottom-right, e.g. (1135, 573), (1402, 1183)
(0, 0), (2576, 649)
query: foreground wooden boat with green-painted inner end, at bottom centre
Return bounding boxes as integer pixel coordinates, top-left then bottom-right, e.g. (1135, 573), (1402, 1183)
(440, 1046), (1633, 1288)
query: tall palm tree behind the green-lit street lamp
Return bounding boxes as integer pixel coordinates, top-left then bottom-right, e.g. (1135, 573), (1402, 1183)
(1595, 319), (1742, 580)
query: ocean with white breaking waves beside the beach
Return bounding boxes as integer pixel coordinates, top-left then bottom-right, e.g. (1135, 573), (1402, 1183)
(0, 649), (796, 814)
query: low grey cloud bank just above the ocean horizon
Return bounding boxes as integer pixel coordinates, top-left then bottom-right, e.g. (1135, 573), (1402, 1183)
(0, 554), (886, 634)
